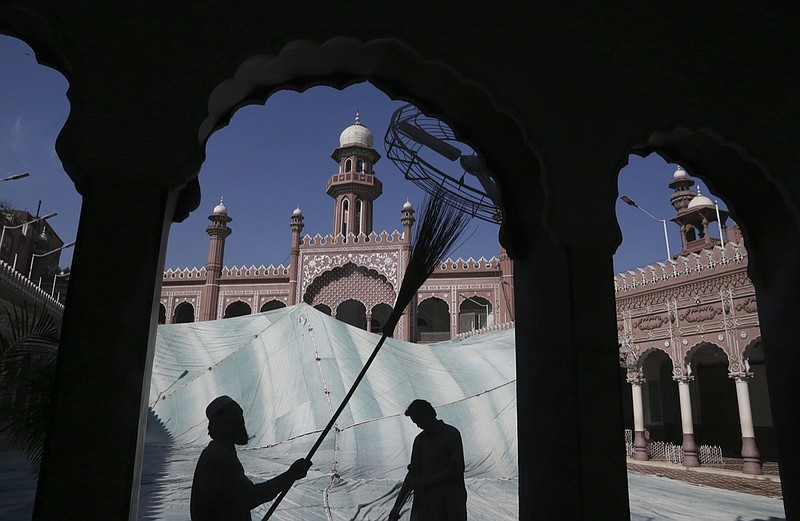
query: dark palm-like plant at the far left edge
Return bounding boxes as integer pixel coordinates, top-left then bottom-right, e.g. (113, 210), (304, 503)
(0, 307), (59, 472)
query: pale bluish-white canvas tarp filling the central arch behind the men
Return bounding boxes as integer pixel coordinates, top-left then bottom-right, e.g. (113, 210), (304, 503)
(140, 304), (518, 521)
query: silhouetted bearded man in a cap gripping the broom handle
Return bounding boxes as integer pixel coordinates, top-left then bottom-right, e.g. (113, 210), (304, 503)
(190, 396), (311, 521)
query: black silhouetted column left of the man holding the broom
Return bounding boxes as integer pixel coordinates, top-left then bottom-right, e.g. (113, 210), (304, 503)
(33, 175), (178, 521)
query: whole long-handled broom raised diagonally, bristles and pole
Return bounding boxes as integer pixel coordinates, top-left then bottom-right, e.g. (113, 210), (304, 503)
(262, 192), (470, 521)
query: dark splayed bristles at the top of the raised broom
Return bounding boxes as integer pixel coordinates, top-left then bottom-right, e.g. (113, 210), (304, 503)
(383, 189), (470, 335)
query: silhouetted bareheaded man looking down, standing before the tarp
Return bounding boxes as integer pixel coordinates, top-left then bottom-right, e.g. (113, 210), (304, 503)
(389, 400), (467, 521)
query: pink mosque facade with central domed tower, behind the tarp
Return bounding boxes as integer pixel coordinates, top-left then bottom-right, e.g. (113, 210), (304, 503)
(159, 115), (514, 343)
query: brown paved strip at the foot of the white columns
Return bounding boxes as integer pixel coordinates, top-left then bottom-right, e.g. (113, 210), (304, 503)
(628, 459), (783, 499)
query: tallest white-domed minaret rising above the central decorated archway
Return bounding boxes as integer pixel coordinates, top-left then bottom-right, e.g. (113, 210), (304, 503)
(327, 112), (383, 240)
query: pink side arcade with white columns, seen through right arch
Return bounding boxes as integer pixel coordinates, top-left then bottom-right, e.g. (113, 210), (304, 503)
(614, 168), (776, 474)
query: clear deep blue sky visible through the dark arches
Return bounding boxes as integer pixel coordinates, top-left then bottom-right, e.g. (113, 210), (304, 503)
(0, 36), (716, 272)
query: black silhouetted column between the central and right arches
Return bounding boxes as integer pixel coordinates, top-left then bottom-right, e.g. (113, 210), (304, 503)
(514, 210), (630, 520)
